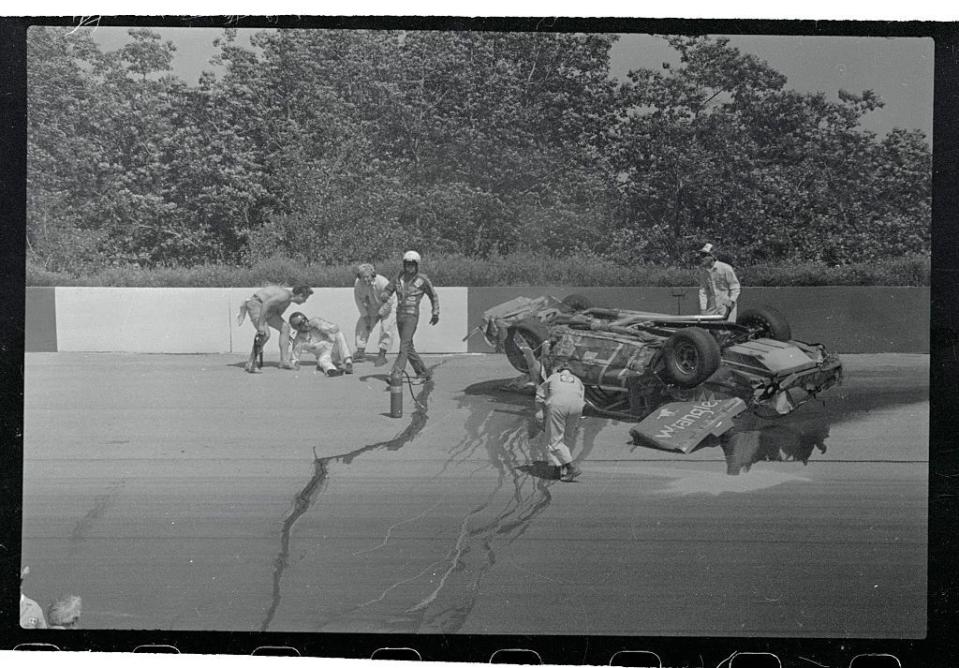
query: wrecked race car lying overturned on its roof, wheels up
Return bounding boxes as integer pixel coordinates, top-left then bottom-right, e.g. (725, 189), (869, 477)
(492, 295), (842, 452)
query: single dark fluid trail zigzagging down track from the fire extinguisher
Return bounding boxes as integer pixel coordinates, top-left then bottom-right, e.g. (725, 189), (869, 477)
(260, 374), (439, 631)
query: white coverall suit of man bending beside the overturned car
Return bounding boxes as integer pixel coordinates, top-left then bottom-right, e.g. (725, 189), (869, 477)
(536, 369), (585, 466)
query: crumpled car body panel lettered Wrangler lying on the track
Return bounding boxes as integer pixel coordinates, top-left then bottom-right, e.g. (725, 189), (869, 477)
(629, 397), (746, 453)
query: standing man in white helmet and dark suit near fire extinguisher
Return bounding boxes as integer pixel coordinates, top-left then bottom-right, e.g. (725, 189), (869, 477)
(379, 251), (440, 382)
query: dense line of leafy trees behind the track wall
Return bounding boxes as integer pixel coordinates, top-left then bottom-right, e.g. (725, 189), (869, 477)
(26, 26), (932, 274)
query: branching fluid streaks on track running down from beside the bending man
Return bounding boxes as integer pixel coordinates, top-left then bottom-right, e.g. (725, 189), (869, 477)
(310, 382), (601, 634)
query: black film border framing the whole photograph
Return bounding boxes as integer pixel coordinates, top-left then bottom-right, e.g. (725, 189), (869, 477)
(0, 11), (959, 668)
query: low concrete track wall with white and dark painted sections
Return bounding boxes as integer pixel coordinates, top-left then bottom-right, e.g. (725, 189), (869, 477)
(24, 287), (930, 354)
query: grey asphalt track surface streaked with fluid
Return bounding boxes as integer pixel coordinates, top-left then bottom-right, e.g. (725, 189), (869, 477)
(23, 351), (929, 638)
